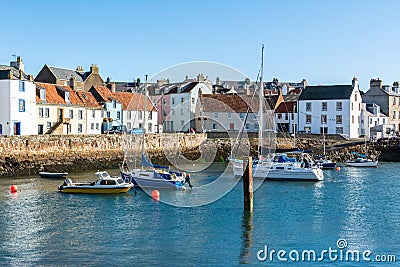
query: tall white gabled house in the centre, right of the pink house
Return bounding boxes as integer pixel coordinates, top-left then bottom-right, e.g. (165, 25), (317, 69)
(164, 82), (212, 132)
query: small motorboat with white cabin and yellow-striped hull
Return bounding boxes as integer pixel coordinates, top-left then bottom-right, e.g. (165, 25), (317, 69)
(58, 171), (133, 194)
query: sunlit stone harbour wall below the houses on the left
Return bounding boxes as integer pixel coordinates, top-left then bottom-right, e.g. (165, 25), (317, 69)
(0, 134), (205, 176)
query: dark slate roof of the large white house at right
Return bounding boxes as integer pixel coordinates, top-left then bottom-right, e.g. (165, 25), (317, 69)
(299, 85), (354, 100)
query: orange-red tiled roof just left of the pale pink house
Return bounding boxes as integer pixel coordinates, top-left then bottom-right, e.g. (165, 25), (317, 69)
(113, 92), (156, 111)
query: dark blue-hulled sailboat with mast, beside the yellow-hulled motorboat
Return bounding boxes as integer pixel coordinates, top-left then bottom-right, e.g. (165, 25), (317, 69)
(120, 75), (192, 189)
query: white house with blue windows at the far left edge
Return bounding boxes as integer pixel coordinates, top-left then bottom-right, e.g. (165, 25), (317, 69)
(0, 57), (37, 135)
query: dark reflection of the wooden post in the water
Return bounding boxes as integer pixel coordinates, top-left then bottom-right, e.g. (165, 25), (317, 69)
(240, 211), (253, 264)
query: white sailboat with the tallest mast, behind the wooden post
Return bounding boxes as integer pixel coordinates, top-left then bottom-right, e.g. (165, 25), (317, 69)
(230, 45), (324, 181)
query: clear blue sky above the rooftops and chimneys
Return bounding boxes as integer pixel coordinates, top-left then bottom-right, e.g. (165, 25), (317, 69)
(0, 0), (400, 90)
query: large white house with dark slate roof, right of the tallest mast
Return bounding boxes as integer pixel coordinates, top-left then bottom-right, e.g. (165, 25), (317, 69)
(298, 78), (362, 138)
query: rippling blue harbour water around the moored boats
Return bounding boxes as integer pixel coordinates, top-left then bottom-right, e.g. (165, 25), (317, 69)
(0, 163), (400, 266)
